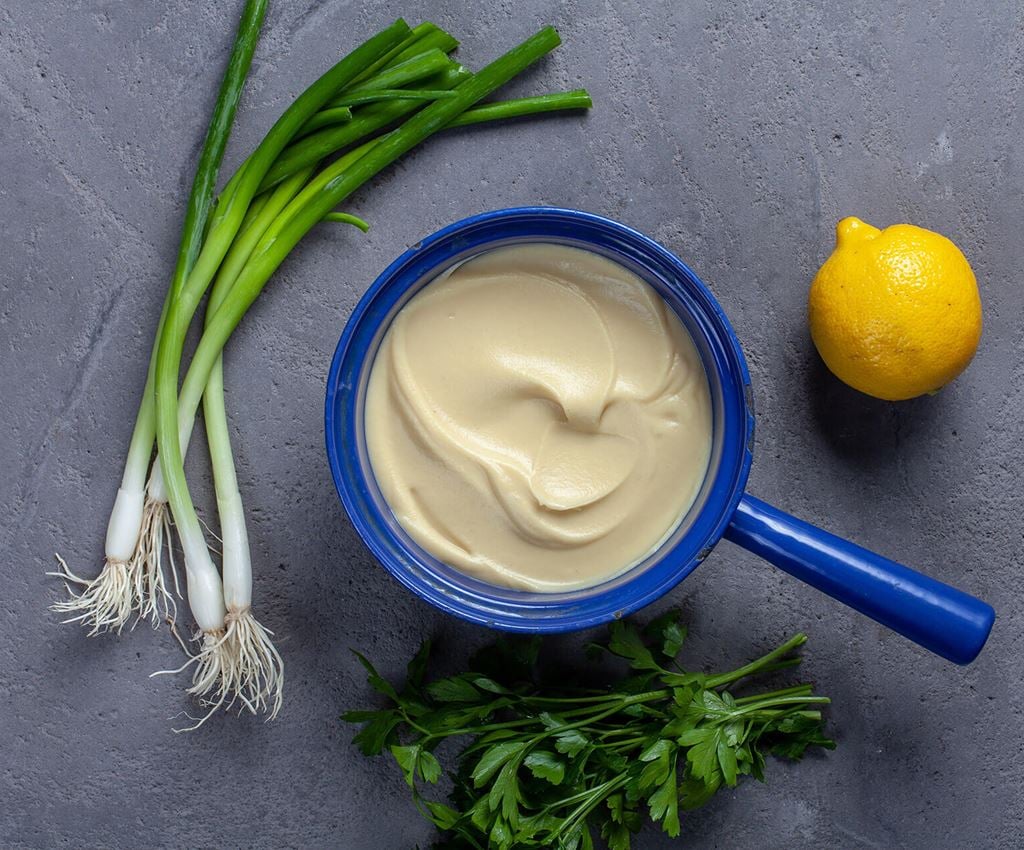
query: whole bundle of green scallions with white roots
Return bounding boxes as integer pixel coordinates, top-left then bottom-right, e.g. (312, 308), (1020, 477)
(54, 0), (591, 725)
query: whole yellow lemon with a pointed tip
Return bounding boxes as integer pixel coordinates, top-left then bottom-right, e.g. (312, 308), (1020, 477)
(808, 216), (981, 401)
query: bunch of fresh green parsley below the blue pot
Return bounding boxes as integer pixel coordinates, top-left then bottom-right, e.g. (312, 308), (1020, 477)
(344, 612), (835, 850)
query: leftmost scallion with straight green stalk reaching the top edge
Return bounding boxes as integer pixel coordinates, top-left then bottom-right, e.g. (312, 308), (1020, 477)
(53, 0), (267, 635)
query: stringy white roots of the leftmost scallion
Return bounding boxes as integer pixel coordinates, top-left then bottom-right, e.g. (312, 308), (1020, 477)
(48, 555), (140, 637)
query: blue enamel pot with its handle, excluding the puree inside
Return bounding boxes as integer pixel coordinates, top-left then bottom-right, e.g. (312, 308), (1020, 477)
(326, 207), (995, 664)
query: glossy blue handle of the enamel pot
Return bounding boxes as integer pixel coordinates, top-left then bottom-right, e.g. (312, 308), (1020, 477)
(725, 495), (995, 664)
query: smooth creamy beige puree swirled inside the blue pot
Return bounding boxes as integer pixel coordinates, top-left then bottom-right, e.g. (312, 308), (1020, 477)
(366, 244), (711, 592)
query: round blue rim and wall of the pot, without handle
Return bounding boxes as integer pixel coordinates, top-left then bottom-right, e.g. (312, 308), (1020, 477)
(325, 207), (754, 632)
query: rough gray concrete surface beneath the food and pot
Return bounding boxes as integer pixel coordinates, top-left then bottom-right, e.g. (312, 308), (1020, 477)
(0, 0), (1024, 850)
